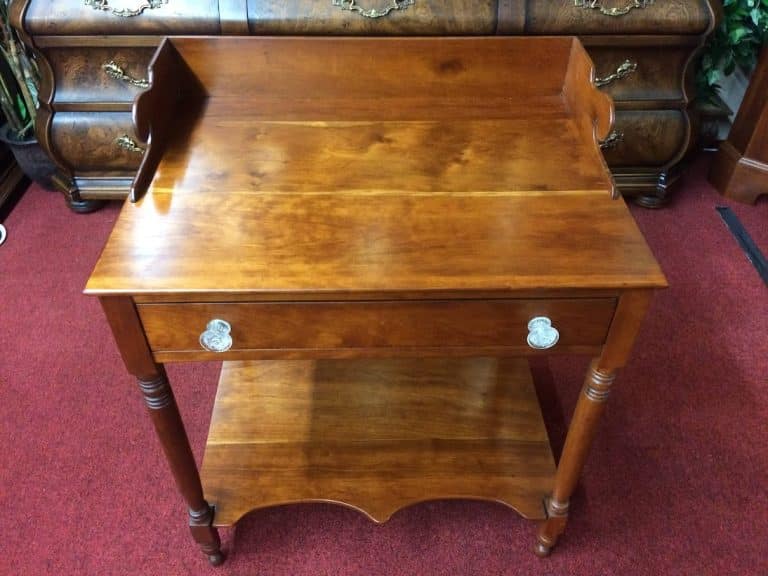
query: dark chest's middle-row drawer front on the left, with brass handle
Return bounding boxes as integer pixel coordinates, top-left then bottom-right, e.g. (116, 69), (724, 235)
(44, 47), (155, 104)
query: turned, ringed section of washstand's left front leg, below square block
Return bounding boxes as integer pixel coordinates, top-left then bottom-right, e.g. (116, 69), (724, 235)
(139, 366), (224, 566)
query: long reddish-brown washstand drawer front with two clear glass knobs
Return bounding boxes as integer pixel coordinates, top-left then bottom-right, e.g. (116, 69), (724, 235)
(138, 298), (616, 353)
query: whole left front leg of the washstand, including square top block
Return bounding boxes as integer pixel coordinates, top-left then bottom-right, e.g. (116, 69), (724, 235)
(101, 297), (224, 566)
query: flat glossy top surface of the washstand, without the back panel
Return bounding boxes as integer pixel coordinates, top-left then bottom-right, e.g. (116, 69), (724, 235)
(87, 40), (665, 299)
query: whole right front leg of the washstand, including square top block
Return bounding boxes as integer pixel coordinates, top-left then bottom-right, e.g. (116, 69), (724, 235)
(536, 290), (651, 556)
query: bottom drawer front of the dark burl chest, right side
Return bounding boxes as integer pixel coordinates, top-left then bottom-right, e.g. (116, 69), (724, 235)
(603, 110), (689, 167)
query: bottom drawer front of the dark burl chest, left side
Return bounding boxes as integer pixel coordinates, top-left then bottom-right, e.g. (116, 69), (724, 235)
(51, 112), (142, 174)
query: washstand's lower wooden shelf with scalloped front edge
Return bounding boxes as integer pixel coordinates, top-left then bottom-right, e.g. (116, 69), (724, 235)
(201, 358), (555, 526)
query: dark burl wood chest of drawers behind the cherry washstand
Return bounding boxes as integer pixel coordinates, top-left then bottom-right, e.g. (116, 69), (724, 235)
(13, 0), (715, 206)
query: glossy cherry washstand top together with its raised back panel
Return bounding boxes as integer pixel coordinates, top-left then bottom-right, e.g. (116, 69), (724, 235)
(88, 38), (664, 300)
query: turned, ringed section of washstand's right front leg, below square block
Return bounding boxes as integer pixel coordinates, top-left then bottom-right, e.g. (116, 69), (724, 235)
(535, 359), (615, 557)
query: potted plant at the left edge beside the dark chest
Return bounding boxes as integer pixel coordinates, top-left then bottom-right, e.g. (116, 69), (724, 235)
(0, 0), (56, 188)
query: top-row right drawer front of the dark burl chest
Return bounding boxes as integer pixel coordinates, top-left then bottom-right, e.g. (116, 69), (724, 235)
(526, 0), (713, 34)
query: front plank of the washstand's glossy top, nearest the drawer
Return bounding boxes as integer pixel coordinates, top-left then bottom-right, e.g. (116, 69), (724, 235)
(88, 194), (663, 300)
